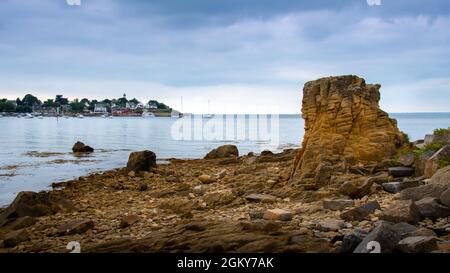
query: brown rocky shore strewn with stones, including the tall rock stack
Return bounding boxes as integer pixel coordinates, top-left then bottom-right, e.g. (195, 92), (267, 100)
(0, 76), (450, 253)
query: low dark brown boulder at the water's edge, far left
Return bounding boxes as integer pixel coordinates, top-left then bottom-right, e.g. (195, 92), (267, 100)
(0, 189), (74, 226)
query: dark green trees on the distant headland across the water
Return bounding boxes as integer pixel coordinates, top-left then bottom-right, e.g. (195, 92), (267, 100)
(0, 94), (171, 113)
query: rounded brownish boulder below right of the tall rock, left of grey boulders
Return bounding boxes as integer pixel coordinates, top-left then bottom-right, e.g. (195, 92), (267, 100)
(381, 200), (422, 224)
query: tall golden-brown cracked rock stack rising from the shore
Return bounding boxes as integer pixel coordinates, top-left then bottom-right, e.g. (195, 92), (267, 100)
(291, 76), (406, 186)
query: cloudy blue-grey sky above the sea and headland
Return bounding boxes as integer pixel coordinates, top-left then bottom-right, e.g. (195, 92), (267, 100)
(0, 0), (450, 114)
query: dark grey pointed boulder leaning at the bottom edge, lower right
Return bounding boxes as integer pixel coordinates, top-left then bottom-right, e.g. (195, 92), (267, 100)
(354, 221), (400, 253)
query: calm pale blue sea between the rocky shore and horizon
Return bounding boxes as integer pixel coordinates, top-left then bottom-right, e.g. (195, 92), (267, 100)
(0, 113), (450, 206)
